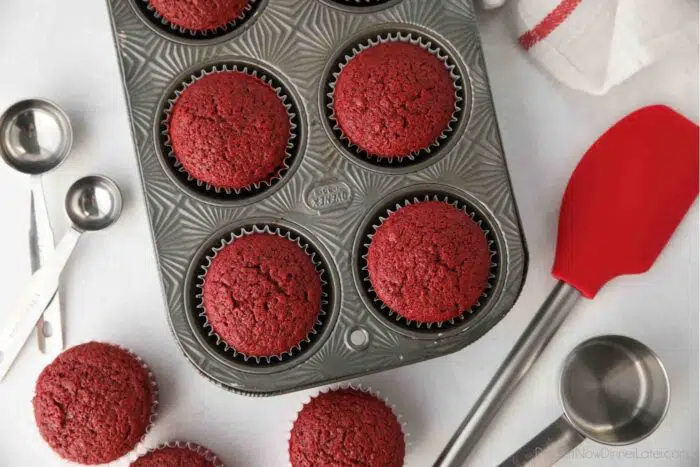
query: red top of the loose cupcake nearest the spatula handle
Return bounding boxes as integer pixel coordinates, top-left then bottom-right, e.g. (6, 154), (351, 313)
(289, 389), (406, 467)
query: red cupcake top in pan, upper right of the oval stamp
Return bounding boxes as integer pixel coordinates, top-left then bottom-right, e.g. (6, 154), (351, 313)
(333, 42), (456, 158)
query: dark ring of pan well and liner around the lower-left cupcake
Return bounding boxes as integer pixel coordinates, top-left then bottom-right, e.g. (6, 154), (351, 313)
(185, 221), (336, 369)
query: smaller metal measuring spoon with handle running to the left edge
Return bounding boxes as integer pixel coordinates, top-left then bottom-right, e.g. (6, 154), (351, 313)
(0, 175), (122, 381)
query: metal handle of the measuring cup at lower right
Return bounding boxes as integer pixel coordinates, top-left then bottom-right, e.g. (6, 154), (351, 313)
(499, 415), (586, 467)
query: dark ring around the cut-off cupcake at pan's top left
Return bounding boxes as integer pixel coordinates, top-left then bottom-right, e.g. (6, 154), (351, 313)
(129, 0), (268, 45)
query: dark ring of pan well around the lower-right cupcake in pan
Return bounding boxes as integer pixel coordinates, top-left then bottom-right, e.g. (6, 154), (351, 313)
(353, 188), (502, 337)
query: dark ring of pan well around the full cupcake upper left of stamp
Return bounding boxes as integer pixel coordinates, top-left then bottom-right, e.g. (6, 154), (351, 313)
(154, 58), (305, 205)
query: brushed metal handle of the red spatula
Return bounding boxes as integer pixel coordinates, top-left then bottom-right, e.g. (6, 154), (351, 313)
(433, 282), (581, 467)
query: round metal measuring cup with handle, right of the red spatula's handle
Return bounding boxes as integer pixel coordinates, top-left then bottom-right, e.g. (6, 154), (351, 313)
(500, 336), (670, 467)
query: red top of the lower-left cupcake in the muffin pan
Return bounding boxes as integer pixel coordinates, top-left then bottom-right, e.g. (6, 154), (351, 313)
(203, 234), (321, 357)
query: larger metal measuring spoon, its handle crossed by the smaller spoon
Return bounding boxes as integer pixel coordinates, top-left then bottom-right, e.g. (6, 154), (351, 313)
(0, 99), (73, 355)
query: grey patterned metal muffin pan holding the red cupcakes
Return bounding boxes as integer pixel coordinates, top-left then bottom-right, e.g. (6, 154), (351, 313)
(107, 0), (527, 396)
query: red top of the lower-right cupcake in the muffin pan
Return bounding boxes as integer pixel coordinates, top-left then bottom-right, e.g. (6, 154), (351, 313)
(367, 201), (491, 323)
